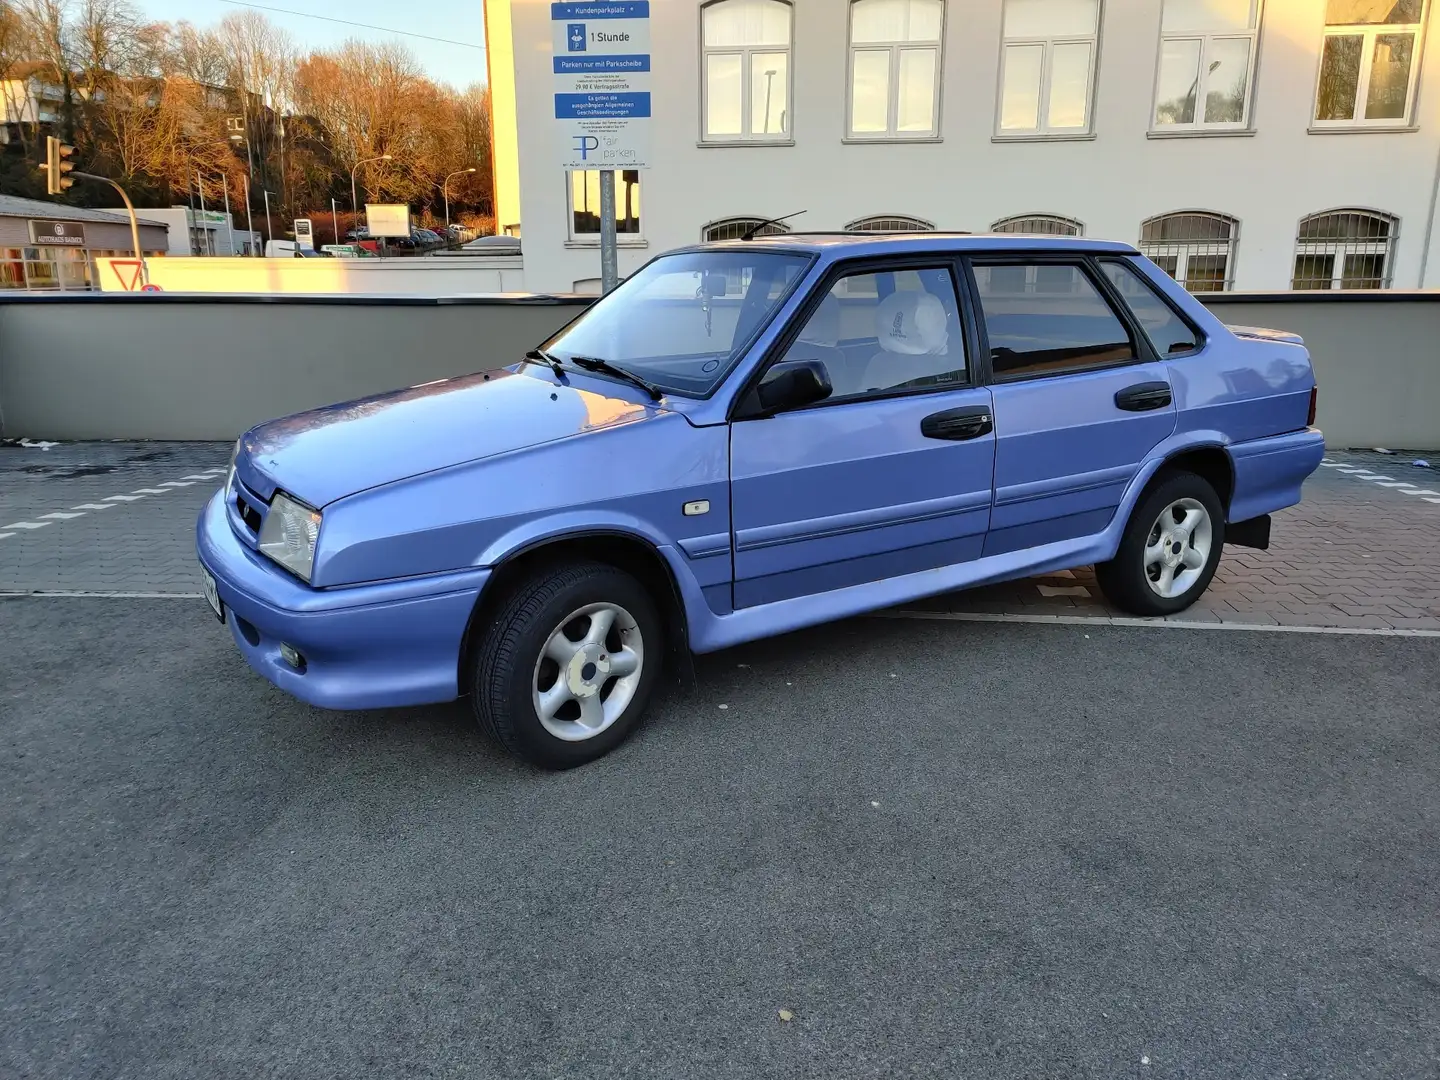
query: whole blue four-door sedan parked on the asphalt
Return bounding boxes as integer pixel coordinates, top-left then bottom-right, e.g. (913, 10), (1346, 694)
(197, 233), (1323, 768)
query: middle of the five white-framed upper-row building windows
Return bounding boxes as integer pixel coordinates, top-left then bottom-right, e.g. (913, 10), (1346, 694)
(998, 0), (1100, 135)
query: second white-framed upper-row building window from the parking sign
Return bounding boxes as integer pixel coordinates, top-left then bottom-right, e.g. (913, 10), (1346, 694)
(848, 0), (945, 138)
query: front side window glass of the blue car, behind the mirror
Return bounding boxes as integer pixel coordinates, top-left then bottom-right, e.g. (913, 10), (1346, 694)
(785, 266), (966, 400)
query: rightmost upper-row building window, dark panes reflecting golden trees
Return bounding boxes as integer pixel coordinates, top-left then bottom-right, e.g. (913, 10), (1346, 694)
(1315, 0), (1427, 128)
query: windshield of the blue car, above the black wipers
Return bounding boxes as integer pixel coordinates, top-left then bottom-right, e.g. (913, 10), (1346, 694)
(543, 251), (809, 395)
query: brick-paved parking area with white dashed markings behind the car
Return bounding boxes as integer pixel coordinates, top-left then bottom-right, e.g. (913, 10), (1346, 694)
(0, 444), (1440, 631)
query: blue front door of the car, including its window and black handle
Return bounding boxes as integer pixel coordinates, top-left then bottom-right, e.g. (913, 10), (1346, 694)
(730, 259), (995, 609)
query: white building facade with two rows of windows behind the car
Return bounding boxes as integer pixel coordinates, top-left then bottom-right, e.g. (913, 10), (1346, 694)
(487, 0), (1440, 292)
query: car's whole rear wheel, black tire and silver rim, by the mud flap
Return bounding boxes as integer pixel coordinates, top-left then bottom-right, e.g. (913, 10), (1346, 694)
(1094, 472), (1225, 615)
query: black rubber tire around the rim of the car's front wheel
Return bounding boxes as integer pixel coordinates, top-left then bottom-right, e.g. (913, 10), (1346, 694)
(469, 563), (665, 769)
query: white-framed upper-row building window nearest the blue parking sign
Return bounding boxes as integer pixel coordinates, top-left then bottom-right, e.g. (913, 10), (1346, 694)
(700, 0), (793, 143)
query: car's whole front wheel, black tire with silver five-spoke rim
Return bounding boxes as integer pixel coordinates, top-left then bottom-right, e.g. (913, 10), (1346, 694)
(471, 563), (664, 769)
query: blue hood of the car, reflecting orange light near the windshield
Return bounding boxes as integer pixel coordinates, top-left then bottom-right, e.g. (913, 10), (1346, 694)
(236, 369), (665, 507)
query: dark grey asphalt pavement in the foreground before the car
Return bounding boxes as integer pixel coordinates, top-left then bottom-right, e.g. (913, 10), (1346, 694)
(0, 598), (1440, 1080)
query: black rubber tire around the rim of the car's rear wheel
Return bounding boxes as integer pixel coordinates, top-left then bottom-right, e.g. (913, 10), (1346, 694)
(1094, 471), (1225, 615)
